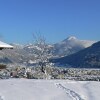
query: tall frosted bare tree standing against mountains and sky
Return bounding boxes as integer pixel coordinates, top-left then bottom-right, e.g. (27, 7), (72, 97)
(33, 34), (52, 73)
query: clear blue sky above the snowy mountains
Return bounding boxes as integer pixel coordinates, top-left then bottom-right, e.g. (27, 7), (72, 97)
(0, 0), (100, 44)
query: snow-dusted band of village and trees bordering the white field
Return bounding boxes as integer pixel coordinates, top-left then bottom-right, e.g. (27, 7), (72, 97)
(0, 65), (100, 81)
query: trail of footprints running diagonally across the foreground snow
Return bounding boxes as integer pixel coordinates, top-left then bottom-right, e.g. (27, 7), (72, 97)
(56, 83), (84, 100)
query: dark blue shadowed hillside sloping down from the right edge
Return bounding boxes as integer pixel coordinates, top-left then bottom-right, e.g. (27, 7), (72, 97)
(53, 42), (100, 68)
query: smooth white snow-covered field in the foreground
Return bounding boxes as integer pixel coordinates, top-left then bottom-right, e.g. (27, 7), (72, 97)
(0, 79), (100, 100)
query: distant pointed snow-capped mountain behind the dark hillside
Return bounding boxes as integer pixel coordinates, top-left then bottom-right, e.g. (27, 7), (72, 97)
(53, 36), (96, 57)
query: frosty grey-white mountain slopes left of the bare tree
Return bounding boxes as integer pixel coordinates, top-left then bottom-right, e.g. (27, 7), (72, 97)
(0, 44), (52, 65)
